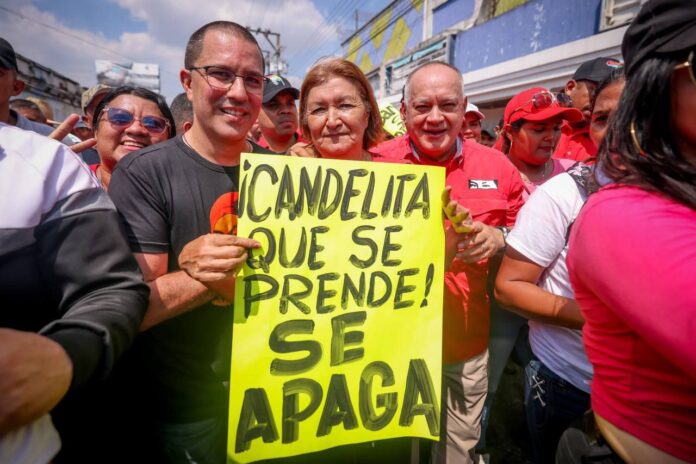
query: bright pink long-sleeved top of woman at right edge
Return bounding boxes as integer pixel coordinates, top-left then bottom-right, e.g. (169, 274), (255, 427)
(567, 185), (696, 462)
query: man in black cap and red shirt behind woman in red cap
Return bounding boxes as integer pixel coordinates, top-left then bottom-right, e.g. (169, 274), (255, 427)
(553, 57), (622, 161)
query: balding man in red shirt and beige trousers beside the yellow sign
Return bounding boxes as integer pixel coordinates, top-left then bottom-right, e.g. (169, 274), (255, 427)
(373, 63), (524, 463)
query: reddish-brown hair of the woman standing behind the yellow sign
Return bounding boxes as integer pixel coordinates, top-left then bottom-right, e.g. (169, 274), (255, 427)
(300, 58), (384, 149)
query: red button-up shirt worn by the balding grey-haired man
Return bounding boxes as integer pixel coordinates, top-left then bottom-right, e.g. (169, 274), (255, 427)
(371, 134), (524, 364)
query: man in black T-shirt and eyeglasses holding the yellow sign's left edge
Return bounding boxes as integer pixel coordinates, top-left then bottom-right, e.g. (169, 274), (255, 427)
(109, 21), (266, 463)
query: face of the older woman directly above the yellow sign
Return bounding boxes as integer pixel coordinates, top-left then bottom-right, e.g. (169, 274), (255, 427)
(304, 77), (369, 159)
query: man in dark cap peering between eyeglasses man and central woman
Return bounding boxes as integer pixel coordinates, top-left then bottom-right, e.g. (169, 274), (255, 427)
(258, 75), (300, 154)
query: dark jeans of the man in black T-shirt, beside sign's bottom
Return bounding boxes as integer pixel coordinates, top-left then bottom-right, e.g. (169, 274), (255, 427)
(158, 415), (227, 464)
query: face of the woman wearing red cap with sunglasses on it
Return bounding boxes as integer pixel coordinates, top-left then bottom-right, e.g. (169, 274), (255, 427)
(508, 117), (561, 166)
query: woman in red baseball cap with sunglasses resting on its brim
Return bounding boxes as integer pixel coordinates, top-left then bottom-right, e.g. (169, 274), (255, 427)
(498, 87), (583, 200)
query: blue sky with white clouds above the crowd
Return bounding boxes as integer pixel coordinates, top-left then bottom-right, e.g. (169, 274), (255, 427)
(0, 0), (390, 101)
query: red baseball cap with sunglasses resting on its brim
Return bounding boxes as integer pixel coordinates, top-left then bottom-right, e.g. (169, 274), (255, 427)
(504, 87), (584, 124)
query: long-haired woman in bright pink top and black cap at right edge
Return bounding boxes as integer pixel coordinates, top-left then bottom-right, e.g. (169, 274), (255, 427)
(567, 0), (696, 463)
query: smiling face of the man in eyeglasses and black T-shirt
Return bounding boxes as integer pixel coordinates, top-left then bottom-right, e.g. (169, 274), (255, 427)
(181, 29), (264, 143)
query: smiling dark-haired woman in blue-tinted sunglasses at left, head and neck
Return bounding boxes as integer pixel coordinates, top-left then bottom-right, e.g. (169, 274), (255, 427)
(90, 86), (176, 190)
